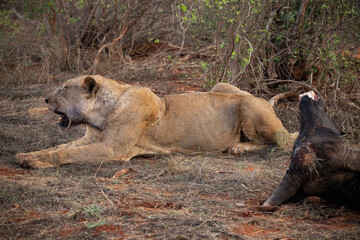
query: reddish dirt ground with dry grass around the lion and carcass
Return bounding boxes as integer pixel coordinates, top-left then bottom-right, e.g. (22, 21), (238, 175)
(0, 57), (360, 239)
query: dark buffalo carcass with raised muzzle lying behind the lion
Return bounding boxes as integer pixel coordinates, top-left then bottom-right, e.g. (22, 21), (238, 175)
(263, 91), (360, 209)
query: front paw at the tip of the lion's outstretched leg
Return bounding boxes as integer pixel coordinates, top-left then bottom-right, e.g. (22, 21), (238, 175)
(15, 152), (55, 168)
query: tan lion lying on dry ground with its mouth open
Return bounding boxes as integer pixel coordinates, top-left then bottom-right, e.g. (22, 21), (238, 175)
(16, 75), (288, 168)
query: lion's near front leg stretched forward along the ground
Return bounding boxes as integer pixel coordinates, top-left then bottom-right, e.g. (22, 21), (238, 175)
(16, 118), (147, 168)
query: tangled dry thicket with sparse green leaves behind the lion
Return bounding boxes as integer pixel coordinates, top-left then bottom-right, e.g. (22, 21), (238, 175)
(0, 0), (360, 96)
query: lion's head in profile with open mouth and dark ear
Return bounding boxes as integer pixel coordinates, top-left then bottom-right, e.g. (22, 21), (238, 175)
(45, 76), (99, 133)
